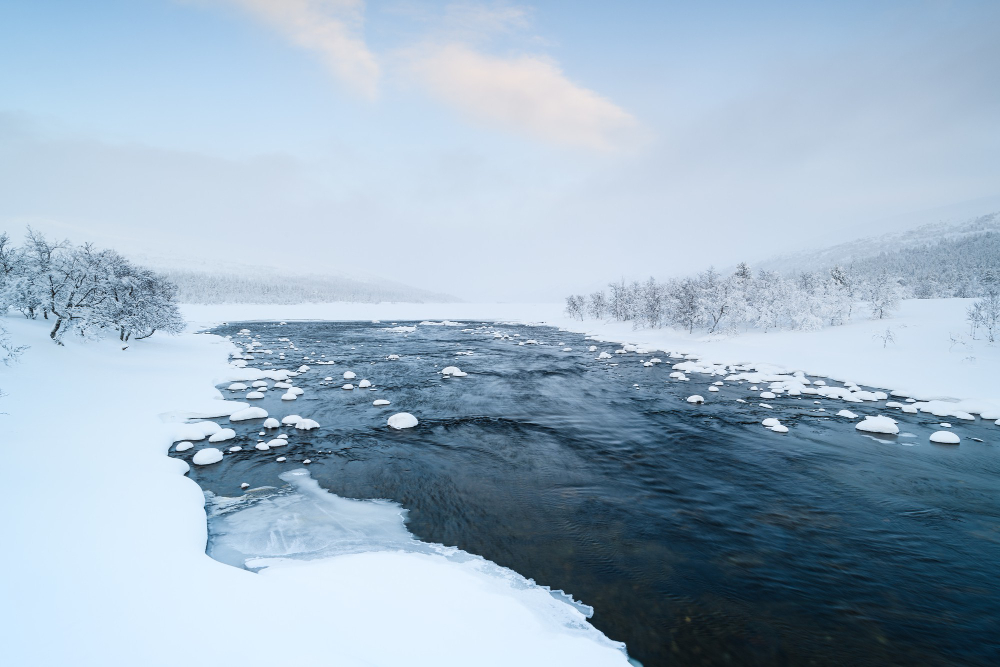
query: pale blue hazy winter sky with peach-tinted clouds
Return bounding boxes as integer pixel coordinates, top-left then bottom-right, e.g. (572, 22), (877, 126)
(0, 0), (1000, 301)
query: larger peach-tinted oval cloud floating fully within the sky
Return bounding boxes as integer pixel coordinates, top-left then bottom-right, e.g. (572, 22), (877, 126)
(407, 43), (639, 150)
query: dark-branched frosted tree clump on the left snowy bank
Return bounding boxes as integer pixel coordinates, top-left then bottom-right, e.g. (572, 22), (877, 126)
(0, 228), (184, 343)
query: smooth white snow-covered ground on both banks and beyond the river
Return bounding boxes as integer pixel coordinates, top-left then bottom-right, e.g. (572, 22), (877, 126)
(0, 300), (1000, 665)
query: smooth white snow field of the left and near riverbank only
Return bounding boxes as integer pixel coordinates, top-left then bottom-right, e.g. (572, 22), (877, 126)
(0, 312), (628, 667)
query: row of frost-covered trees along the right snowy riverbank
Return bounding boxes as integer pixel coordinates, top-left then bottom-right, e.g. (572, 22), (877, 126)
(566, 263), (905, 333)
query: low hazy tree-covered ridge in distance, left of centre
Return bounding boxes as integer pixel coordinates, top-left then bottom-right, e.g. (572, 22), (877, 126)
(164, 269), (456, 305)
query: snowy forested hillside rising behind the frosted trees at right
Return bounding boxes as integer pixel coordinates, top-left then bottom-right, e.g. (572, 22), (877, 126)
(755, 212), (1000, 298)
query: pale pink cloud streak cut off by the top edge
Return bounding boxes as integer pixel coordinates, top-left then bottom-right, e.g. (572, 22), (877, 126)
(227, 0), (379, 99)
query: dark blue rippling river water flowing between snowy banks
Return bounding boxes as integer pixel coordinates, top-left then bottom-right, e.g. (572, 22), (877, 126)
(172, 322), (1000, 667)
